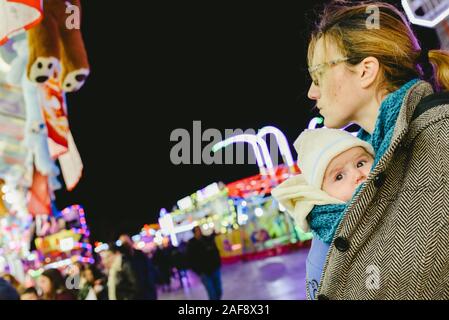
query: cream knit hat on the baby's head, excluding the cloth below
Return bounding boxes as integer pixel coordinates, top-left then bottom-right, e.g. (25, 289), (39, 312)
(294, 128), (374, 189)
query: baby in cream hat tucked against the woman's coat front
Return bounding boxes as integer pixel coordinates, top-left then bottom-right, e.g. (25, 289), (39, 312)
(272, 128), (374, 299)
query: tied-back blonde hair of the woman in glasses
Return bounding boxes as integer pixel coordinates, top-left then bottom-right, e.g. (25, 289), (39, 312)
(308, 1), (449, 92)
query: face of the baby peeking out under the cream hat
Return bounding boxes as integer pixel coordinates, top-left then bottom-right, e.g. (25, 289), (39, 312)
(322, 147), (373, 202)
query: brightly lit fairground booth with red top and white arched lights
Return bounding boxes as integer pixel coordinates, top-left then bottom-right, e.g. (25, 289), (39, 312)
(128, 126), (319, 262)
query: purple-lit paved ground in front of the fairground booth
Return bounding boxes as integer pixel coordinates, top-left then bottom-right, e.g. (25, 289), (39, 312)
(159, 249), (308, 300)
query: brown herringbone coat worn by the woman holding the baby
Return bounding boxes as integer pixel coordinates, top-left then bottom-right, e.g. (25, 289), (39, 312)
(318, 81), (449, 299)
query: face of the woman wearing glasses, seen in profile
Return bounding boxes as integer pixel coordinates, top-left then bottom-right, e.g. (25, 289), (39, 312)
(308, 38), (361, 129)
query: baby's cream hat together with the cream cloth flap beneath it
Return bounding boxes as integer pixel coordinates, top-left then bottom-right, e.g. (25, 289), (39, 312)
(271, 128), (374, 232)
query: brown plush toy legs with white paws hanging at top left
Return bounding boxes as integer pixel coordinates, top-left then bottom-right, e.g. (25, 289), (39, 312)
(27, 0), (89, 92)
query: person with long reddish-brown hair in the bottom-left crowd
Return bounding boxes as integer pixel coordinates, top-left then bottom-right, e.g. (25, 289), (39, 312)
(38, 269), (76, 300)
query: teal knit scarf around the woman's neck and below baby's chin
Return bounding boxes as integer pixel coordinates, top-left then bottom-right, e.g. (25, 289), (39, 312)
(309, 79), (419, 244)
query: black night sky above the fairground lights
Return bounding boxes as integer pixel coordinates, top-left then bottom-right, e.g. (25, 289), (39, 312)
(56, 0), (438, 241)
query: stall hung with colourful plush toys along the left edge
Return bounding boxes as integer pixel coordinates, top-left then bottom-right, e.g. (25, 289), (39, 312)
(0, 0), (89, 280)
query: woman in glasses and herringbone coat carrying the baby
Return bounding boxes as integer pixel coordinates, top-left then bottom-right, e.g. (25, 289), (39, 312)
(308, 1), (449, 299)
